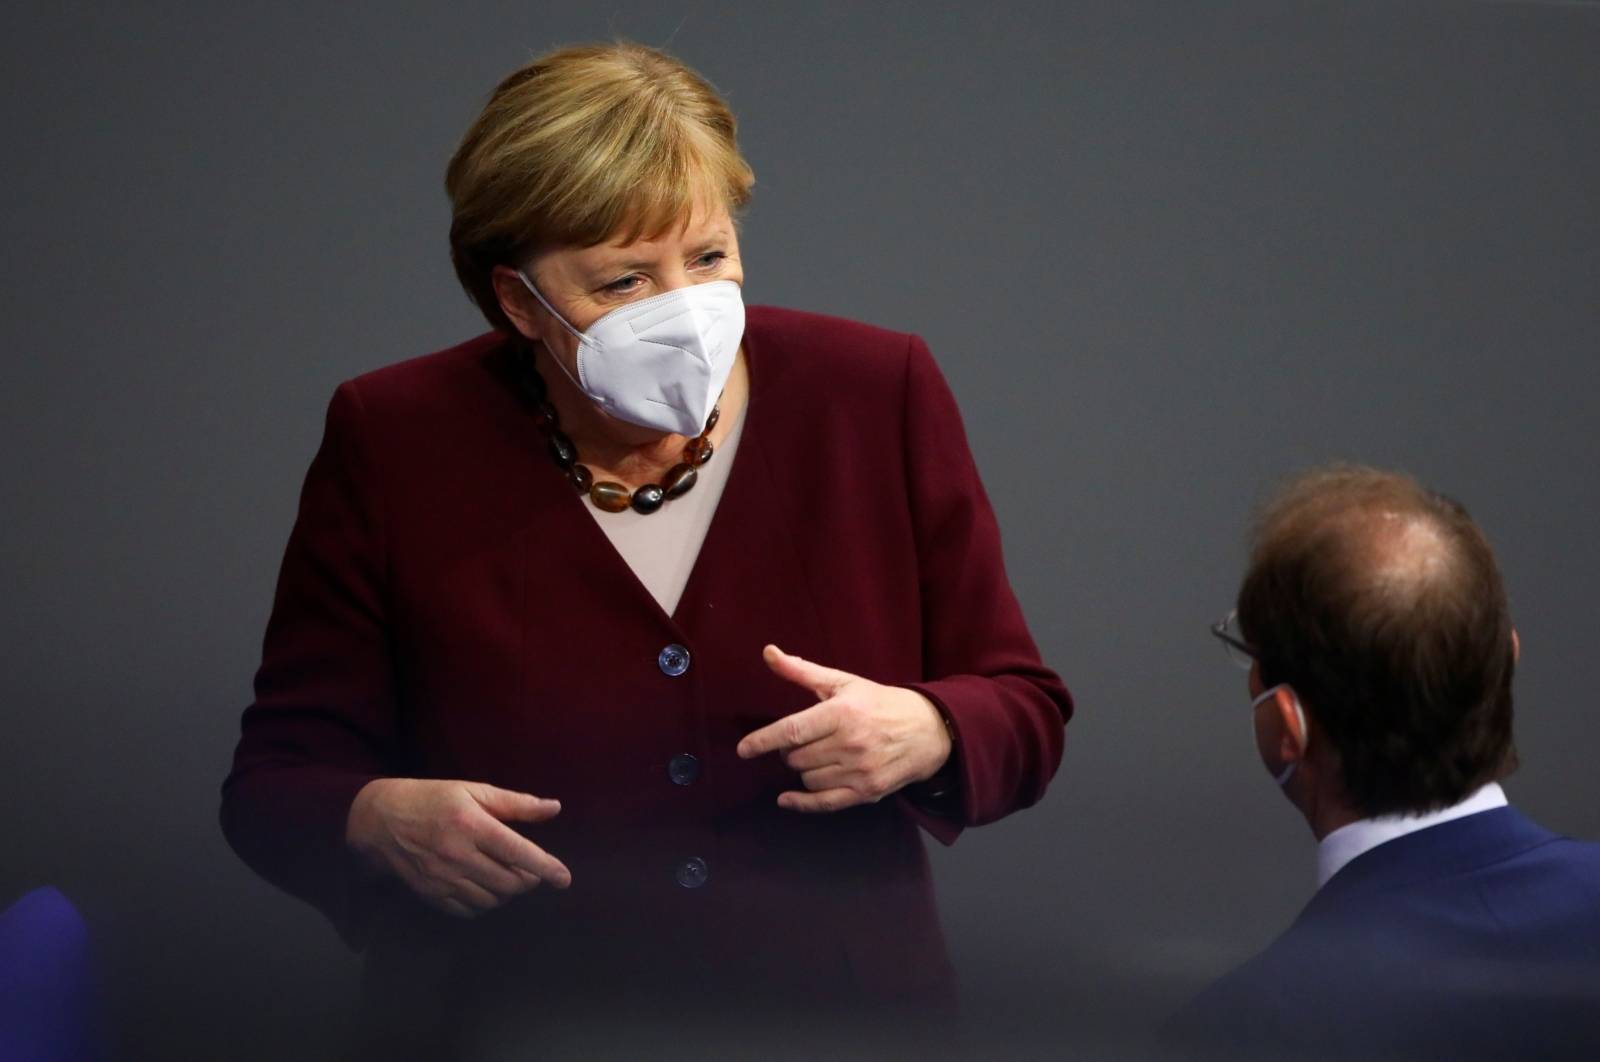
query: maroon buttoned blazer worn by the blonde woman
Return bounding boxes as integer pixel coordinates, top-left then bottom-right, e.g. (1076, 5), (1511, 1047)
(222, 307), (1072, 1036)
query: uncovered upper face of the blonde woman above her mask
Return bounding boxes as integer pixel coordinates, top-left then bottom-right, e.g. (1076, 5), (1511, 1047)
(512, 206), (744, 374)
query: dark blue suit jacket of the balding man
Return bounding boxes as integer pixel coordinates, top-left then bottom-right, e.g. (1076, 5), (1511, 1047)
(1173, 808), (1600, 1060)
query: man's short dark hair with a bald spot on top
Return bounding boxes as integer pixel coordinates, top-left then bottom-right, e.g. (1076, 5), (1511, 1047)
(1238, 465), (1517, 816)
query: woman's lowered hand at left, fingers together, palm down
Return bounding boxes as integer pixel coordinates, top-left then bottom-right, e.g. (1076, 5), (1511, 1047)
(344, 777), (573, 918)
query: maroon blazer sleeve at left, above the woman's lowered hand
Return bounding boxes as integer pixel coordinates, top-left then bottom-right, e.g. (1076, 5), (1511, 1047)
(221, 382), (395, 947)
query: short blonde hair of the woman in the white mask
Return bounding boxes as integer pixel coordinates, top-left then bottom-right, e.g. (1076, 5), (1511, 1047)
(445, 43), (755, 331)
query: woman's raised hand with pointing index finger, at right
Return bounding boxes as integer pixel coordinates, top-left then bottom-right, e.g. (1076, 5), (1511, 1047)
(739, 645), (950, 811)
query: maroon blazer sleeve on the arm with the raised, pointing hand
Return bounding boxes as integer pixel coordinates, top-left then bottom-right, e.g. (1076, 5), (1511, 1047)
(902, 336), (1072, 844)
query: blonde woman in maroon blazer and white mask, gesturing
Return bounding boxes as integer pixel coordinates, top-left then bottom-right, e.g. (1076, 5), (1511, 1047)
(222, 43), (1070, 1056)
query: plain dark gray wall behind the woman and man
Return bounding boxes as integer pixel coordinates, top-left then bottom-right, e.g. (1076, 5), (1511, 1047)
(0, 0), (1600, 1059)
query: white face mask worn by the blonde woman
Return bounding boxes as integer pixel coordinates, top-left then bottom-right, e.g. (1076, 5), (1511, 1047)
(517, 278), (744, 435)
